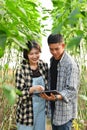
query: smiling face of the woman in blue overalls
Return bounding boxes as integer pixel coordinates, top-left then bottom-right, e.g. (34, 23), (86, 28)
(28, 48), (40, 64)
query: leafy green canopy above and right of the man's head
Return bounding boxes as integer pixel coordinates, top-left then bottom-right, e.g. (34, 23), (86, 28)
(52, 0), (87, 55)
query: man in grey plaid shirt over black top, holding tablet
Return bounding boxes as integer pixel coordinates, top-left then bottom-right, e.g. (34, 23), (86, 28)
(41, 34), (79, 130)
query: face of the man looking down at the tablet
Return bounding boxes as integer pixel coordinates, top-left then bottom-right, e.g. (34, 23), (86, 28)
(49, 43), (65, 60)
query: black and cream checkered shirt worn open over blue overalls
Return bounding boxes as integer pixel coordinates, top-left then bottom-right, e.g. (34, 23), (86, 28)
(16, 60), (48, 125)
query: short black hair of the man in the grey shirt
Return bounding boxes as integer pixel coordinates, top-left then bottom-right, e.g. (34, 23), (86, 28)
(47, 34), (63, 45)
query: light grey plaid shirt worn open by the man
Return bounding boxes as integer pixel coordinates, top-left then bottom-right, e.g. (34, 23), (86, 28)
(48, 52), (79, 126)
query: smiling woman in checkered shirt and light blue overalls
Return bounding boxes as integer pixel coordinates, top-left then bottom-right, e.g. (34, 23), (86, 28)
(16, 41), (48, 130)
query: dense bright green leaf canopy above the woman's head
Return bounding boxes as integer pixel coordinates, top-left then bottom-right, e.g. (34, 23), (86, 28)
(0, 0), (41, 57)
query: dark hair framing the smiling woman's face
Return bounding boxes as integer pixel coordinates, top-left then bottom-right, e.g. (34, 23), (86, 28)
(23, 41), (41, 60)
